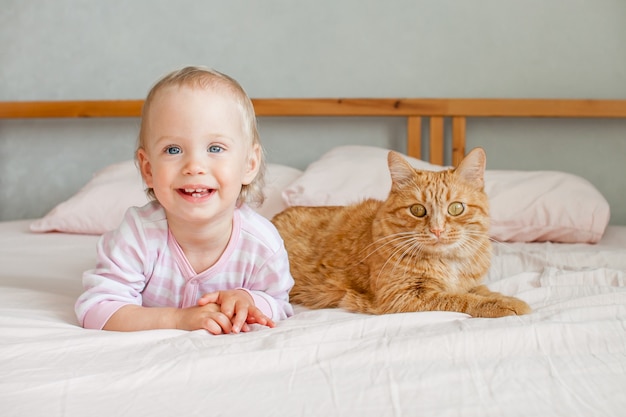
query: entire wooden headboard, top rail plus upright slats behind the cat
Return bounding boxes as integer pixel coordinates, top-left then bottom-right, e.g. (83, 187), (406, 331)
(0, 98), (626, 165)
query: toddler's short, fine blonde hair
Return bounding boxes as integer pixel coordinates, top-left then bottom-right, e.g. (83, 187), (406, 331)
(135, 66), (265, 206)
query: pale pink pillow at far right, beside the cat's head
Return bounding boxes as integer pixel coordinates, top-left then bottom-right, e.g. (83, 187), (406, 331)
(485, 170), (611, 243)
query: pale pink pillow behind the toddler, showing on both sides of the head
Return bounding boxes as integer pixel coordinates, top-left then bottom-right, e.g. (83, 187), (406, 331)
(30, 160), (302, 235)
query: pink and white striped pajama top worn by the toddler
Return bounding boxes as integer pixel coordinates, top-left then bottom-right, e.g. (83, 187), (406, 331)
(76, 201), (293, 329)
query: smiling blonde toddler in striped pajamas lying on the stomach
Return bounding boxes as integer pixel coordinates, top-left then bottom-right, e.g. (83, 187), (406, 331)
(76, 67), (293, 334)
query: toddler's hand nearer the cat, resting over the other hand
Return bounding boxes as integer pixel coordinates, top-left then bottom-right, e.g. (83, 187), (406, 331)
(198, 289), (275, 333)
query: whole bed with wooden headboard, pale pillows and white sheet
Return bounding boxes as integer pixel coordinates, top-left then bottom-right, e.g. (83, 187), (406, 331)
(0, 99), (626, 417)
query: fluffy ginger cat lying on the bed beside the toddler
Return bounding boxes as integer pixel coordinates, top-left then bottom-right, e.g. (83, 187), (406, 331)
(272, 148), (530, 317)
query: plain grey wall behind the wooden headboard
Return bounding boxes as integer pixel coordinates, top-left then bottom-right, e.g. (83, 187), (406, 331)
(0, 0), (626, 224)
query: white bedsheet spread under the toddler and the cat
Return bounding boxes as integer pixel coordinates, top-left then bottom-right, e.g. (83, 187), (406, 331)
(0, 221), (626, 417)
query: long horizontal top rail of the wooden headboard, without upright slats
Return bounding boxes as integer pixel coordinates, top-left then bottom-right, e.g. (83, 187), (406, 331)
(0, 98), (626, 119)
